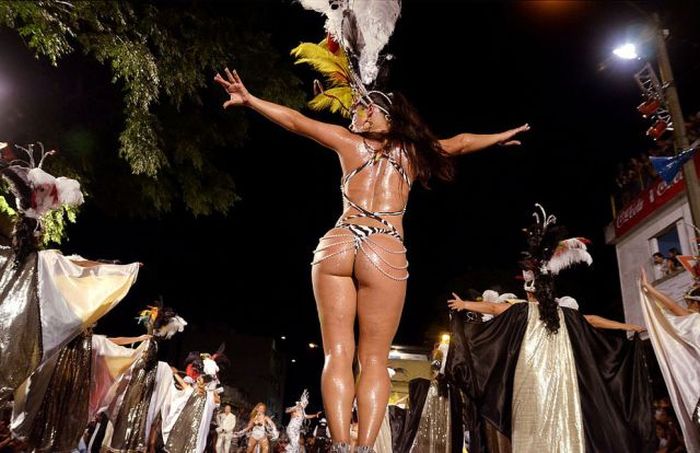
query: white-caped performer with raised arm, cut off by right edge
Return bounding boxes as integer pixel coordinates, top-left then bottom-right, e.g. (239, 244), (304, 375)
(640, 269), (700, 451)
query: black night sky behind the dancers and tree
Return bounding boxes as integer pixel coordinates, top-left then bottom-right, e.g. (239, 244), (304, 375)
(0, 0), (700, 404)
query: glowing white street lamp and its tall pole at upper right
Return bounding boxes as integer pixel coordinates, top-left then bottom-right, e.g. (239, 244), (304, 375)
(613, 13), (700, 225)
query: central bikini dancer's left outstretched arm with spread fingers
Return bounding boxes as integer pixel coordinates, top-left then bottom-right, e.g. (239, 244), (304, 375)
(214, 68), (358, 152)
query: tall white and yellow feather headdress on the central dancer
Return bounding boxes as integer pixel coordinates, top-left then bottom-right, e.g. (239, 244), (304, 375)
(292, 0), (401, 117)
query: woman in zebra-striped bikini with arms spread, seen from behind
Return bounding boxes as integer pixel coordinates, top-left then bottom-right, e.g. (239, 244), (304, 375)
(215, 0), (528, 452)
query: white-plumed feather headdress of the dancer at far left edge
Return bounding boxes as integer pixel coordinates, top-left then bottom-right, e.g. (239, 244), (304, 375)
(0, 143), (83, 220)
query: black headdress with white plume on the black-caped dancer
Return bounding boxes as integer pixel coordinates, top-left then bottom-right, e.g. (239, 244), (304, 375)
(521, 204), (593, 292)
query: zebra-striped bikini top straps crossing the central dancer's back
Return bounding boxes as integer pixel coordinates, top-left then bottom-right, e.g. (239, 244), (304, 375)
(336, 141), (411, 240)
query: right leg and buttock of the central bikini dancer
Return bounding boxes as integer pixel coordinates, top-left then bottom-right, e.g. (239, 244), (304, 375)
(355, 235), (406, 447)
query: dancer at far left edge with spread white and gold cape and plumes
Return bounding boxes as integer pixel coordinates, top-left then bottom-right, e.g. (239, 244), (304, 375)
(0, 143), (139, 407)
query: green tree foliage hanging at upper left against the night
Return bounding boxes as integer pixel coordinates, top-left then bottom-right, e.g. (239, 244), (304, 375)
(0, 0), (303, 226)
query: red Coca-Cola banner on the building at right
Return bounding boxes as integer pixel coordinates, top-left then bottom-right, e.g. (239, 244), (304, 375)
(615, 171), (685, 237)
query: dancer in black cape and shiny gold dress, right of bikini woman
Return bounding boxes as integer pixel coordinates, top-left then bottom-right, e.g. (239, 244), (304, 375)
(448, 205), (654, 452)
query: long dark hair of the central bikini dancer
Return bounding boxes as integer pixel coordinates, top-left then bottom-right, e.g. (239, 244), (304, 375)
(370, 93), (455, 187)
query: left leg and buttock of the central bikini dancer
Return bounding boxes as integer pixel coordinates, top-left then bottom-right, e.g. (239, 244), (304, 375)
(311, 230), (357, 443)
